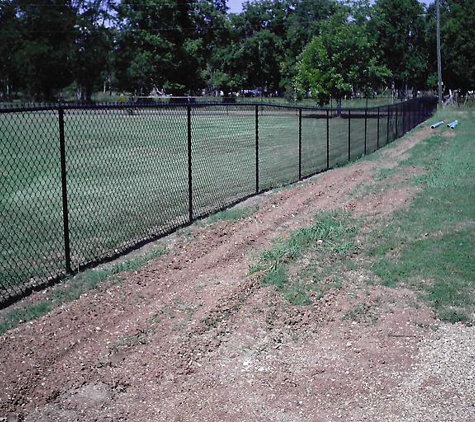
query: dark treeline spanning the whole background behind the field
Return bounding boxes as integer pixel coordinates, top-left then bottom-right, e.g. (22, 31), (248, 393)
(0, 0), (475, 101)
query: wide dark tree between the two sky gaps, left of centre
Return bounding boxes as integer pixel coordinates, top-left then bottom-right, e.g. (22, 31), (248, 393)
(116, 0), (233, 94)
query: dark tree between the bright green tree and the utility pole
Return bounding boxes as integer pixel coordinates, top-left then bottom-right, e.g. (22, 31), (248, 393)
(370, 0), (427, 91)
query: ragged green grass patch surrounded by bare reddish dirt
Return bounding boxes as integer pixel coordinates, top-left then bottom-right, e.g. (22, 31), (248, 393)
(251, 211), (356, 305)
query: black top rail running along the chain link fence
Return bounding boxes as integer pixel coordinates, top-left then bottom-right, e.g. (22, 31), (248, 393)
(0, 97), (437, 114)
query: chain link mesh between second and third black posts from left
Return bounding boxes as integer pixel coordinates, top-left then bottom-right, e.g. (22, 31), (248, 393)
(191, 106), (256, 218)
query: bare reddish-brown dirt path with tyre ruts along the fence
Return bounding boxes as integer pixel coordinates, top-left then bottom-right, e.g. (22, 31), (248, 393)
(0, 129), (475, 422)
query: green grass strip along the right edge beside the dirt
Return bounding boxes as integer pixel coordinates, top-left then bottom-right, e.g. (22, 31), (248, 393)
(370, 112), (475, 322)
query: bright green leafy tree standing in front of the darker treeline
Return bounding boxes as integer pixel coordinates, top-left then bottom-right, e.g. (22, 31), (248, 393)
(296, 13), (391, 105)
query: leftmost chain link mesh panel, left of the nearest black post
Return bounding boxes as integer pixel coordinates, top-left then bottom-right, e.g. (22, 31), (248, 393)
(0, 110), (65, 301)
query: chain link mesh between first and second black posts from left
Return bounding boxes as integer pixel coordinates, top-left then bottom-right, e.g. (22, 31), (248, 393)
(65, 107), (188, 269)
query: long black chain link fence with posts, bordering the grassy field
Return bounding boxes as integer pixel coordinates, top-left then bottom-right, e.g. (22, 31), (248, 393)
(0, 98), (437, 307)
